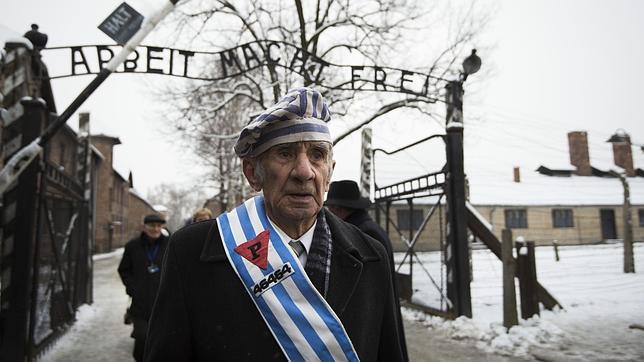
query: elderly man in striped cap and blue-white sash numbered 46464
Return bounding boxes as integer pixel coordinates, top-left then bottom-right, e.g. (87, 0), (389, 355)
(146, 88), (403, 361)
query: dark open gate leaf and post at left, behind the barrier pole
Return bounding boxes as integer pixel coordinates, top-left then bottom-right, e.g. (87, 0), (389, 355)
(0, 39), (93, 361)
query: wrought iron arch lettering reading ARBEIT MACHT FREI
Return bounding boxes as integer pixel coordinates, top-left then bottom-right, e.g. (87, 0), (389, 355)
(45, 40), (443, 100)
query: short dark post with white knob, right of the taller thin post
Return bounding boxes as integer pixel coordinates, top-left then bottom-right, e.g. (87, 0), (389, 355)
(516, 241), (539, 319)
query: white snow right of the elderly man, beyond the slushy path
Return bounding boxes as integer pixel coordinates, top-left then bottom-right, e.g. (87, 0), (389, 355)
(397, 243), (644, 361)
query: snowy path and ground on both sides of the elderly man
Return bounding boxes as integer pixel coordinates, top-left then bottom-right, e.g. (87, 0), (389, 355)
(41, 243), (644, 362)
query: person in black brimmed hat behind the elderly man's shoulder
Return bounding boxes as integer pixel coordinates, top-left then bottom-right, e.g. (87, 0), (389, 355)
(324, 180), (407, 359)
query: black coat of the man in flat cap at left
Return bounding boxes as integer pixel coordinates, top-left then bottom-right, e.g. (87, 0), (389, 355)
(118, 233), (168, 320)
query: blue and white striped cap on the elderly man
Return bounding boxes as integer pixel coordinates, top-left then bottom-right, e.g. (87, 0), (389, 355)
(235, 87), (333, 157)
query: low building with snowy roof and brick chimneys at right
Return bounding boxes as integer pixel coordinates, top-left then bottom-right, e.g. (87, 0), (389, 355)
(381, 132), (644, 251)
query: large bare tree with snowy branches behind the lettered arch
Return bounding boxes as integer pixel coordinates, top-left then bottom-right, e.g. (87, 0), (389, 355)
(165, 0), (486, 210)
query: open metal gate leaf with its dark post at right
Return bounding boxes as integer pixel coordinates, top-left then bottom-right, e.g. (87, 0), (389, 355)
(372, 77), (472, 318)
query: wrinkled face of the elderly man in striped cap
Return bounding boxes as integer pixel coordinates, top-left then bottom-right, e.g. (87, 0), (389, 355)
(244, 141), (335, 237)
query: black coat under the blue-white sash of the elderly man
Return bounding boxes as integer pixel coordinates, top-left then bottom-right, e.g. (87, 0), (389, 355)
(145, 210), (403, 362)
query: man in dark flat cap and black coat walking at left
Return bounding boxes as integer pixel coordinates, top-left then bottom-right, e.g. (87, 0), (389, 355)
(118, 214), (167, 361)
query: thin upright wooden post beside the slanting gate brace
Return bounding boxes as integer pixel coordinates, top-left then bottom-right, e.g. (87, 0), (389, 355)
(501, 229), (519, 329)
